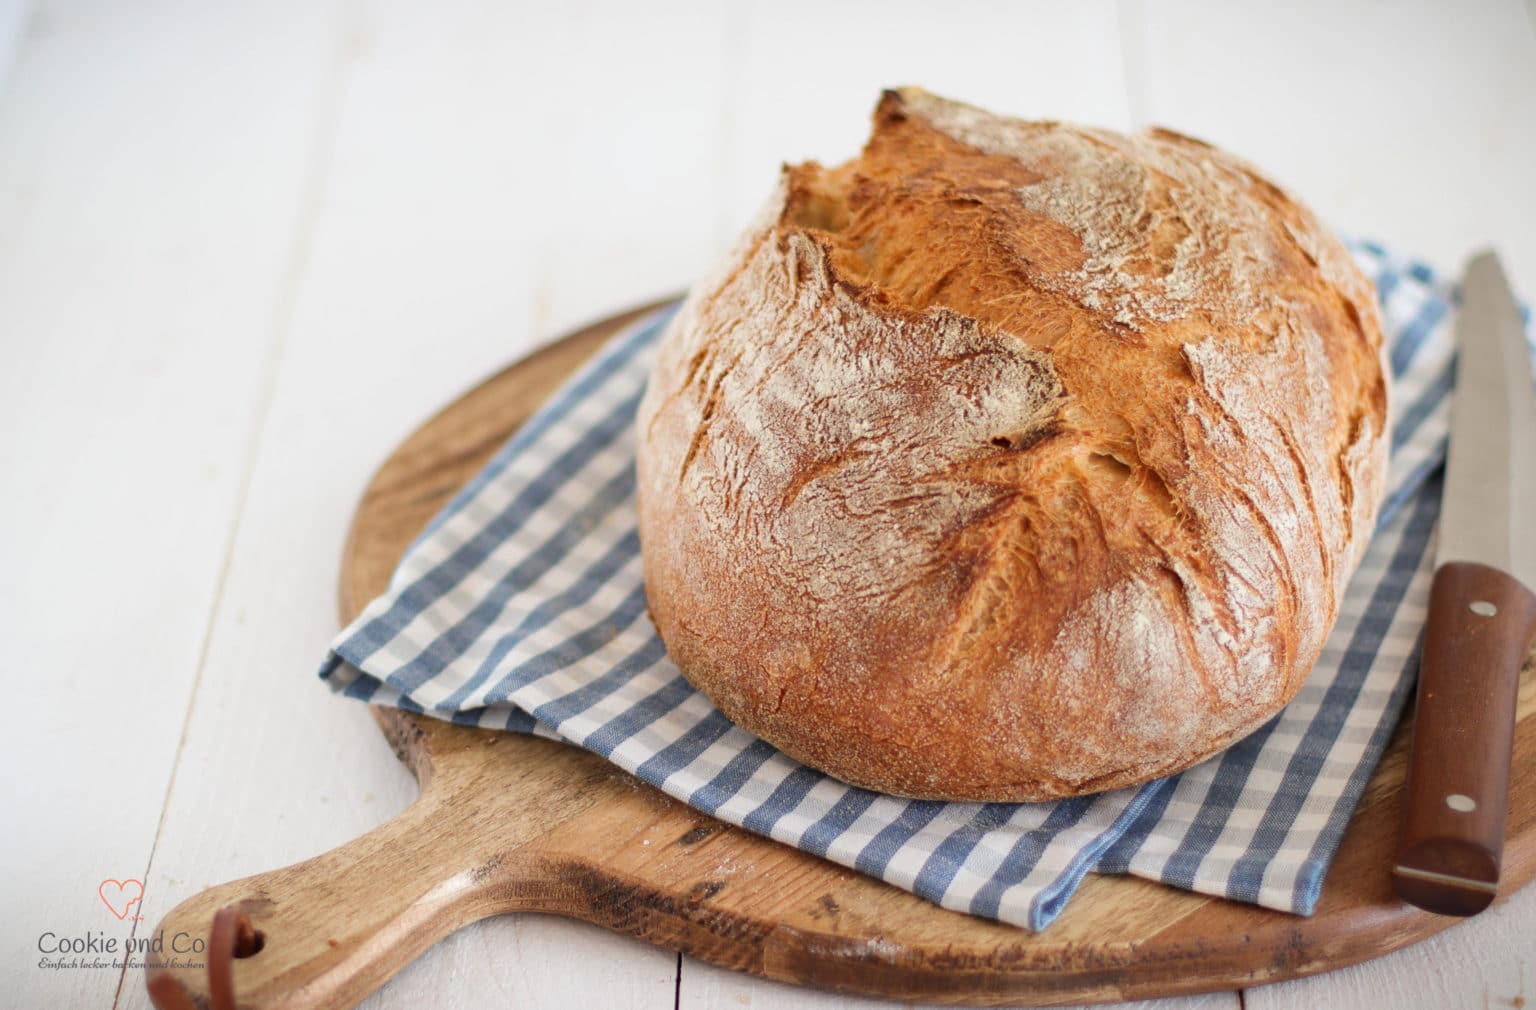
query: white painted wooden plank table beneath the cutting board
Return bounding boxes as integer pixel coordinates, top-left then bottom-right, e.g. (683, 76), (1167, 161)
(0, 0), (1536, 1010)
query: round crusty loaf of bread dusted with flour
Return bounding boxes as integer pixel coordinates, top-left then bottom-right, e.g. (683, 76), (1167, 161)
(637, 89), (1387, 801)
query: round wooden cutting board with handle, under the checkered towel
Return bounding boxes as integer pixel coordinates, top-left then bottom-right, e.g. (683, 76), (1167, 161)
(146, 305), (1536, 1010)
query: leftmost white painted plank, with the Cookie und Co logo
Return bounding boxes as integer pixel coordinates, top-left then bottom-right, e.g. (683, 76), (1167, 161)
(0, 3), (345, 1007)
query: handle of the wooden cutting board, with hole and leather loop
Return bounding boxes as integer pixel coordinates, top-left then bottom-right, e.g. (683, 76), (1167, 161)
(146, 770), (533, 1010)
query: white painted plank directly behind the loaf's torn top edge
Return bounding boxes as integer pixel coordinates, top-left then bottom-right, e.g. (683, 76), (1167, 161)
(720, 0), (1129, 247)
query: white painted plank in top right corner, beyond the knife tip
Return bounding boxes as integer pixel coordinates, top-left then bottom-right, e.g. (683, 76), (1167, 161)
(1124, 0), (1536, 298)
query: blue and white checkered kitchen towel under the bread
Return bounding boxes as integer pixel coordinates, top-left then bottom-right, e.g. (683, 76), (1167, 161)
(321, 244), (1529, 929)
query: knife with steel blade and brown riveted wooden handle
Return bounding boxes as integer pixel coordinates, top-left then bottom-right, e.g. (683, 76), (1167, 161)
(1392, 252), (1536, 915)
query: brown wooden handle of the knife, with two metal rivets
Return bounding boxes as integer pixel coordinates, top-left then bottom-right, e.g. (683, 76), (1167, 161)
(1392, 562), (1536, 915)
